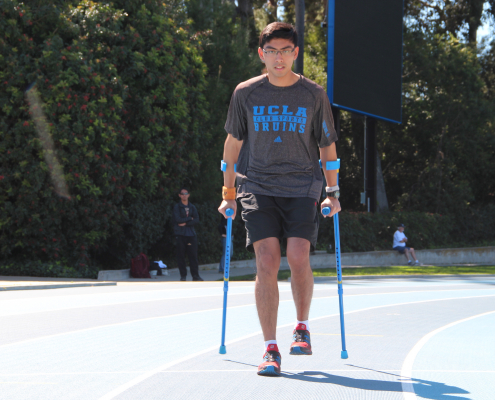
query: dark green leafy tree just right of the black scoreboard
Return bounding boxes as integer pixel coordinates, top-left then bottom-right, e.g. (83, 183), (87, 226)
(380, 31), (495, 214)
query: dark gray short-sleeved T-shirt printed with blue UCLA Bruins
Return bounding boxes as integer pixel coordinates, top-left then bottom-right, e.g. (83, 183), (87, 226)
(225, 75), (337, 200)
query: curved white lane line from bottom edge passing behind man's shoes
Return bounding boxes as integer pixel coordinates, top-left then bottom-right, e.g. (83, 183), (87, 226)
(99, 294), (495, 400)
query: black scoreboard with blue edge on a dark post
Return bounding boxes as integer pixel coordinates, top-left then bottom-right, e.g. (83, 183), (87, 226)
(327, 0), (404, 211)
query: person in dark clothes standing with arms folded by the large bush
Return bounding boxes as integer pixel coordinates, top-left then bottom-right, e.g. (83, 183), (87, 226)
(174, 188), (203, 281)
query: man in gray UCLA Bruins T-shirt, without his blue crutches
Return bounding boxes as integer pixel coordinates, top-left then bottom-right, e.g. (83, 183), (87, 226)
(218, 22), (340, 376)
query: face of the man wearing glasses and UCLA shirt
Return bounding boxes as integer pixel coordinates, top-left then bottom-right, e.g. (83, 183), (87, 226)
(258, 39), (299, 78)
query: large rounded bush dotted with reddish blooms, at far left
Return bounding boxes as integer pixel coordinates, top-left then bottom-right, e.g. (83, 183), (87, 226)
(0, 0), (207, 274)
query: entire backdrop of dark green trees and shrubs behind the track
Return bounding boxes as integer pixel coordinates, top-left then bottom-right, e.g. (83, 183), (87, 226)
(0, 0), (495, 277)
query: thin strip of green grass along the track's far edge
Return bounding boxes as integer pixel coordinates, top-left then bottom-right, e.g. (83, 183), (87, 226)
(227, 265), (495, 281)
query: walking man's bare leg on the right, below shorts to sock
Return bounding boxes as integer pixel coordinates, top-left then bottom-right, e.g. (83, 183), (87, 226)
(287, 237), (314, 321)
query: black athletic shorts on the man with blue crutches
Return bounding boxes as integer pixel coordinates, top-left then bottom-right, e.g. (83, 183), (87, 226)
(240, 194), (319, 252)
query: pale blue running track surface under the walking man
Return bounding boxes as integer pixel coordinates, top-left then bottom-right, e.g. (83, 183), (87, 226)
(0, 277), (495, 400)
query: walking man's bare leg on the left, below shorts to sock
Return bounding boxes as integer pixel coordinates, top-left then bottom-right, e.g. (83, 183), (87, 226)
(253, 237), (280, 341)
